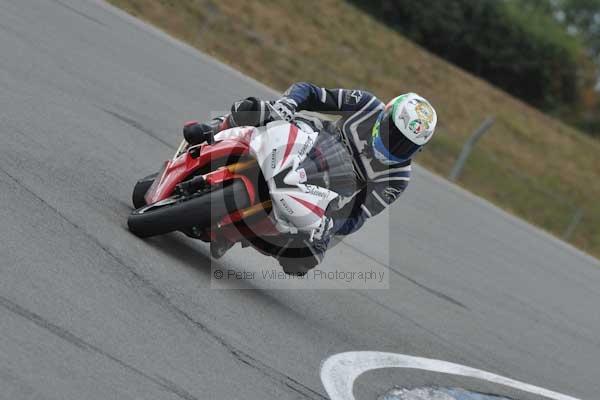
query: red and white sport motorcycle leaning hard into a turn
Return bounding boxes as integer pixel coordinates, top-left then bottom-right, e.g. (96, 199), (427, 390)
(127, 114), (359, 274)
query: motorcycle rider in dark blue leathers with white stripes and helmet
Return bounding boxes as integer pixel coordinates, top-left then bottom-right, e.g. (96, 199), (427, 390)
(183, 82), (437, 272)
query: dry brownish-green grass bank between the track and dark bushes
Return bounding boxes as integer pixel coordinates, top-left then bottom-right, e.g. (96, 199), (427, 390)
(109, 0), (600, 256)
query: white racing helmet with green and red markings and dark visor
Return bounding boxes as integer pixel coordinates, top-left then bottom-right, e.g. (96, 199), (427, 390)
(372, 93), (437, 165)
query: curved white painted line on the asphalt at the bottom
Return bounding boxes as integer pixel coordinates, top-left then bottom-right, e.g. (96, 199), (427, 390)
(321, 351), (580, 400)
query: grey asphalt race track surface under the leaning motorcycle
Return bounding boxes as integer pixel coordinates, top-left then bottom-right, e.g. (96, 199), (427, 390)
(0, 0), (600, 400)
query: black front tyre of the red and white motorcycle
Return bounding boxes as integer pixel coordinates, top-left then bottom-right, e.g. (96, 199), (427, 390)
(127, 179), (250, 237)
